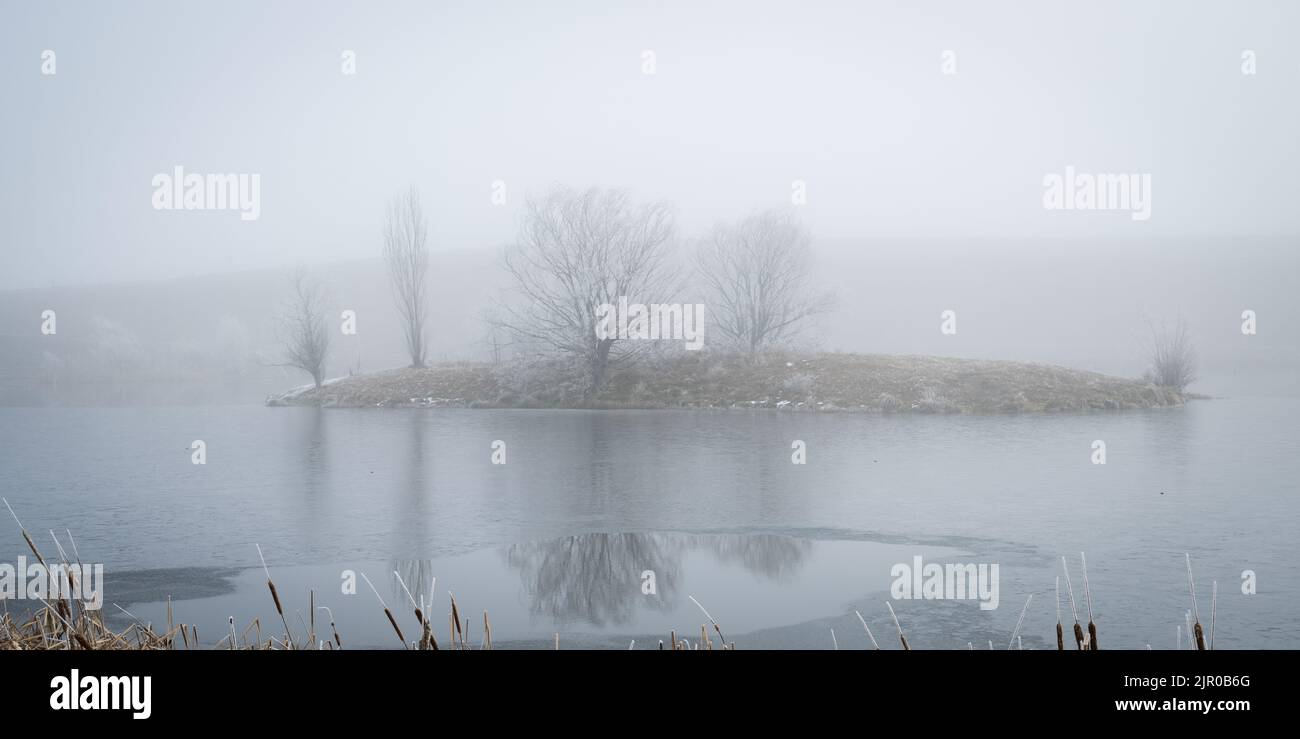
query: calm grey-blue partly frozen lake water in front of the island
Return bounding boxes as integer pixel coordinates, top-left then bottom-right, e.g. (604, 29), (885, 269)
(0, 398), (1300, 648)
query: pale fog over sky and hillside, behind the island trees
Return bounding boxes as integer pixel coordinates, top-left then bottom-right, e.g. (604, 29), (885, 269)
(0, 3), (1300, 402)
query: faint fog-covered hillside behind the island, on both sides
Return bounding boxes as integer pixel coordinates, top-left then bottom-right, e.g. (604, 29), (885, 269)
(0, 239), (1300, 405)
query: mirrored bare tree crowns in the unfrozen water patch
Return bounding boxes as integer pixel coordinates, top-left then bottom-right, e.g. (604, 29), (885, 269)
(503, 533), (813, 626)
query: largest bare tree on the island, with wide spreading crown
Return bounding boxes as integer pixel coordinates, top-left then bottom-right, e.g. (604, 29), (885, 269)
(499, 187), (679, 397)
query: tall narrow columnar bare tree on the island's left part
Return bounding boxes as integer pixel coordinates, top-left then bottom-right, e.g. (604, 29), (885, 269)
(384, 187), (429, 367)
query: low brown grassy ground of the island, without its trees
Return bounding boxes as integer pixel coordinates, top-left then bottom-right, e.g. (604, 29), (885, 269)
(268, 351), (1187, 414)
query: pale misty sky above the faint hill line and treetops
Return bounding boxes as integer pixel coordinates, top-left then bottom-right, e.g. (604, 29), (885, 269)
(0, 0), (1300, 288)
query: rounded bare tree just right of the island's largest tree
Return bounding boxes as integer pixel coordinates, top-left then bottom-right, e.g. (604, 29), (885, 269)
(696, 211), (833, 353)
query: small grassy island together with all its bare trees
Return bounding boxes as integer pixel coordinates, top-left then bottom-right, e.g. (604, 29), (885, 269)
(267, 186), (1196, 415)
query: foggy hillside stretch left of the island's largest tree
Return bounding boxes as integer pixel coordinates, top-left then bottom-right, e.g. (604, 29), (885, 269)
(0, 250), (497, 405)
